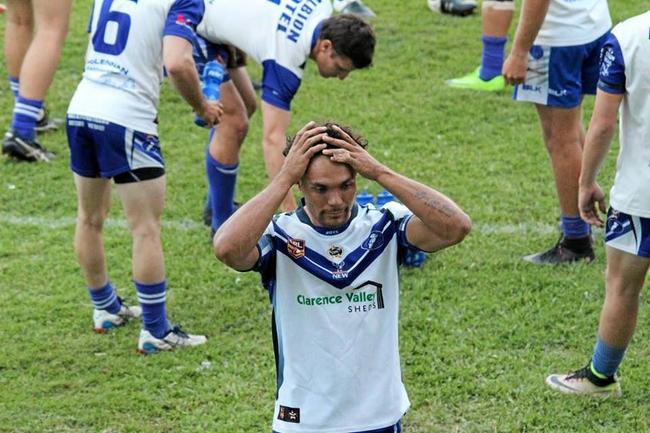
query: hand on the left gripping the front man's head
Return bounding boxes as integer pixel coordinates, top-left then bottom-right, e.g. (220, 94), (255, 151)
(279, 122), (327, 184)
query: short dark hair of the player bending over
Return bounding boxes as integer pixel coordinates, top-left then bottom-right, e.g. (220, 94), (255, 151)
(318, 14), (377, 69)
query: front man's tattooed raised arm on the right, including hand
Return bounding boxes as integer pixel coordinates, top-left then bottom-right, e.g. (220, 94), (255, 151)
(323, 128), (472, 251)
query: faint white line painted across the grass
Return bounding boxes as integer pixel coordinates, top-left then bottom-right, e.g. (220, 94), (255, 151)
(0, 213), (559, 235)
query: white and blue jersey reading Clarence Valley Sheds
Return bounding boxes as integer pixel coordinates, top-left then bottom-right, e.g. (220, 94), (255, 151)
(255, 202), (412, 433)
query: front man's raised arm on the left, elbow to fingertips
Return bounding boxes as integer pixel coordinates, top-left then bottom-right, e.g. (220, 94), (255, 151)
(213, 122), (325, 271)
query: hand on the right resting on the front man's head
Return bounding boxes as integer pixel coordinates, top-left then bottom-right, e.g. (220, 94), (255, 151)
(323, 125), (385, 180)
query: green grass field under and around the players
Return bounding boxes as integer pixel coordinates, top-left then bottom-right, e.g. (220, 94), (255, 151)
(0, 0), (650, 433)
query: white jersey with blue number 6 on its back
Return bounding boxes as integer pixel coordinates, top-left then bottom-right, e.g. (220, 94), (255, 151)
(68, 0), (204, 135)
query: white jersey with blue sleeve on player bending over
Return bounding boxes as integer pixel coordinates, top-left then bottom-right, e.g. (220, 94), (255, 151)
(197, 0), (332, 111)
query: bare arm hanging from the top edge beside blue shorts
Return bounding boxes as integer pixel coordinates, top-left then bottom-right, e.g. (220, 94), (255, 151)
(503, 0), (550, 84)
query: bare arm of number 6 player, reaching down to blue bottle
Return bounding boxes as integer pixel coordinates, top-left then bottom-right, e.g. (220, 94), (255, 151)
(163, 35), (223, 125)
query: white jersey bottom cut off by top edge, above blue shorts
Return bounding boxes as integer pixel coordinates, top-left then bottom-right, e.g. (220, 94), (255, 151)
(535, 0), (612, 47)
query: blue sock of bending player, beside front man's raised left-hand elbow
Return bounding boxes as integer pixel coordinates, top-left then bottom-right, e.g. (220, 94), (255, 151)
(205, 150), (239, 231)
